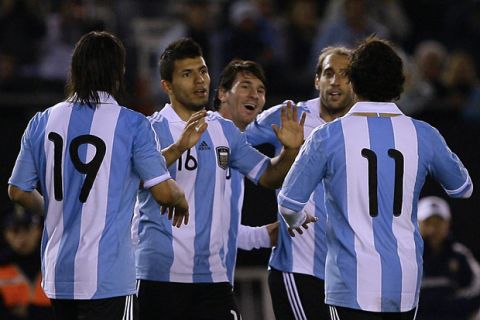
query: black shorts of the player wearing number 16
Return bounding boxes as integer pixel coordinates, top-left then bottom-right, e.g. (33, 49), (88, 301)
(137, 280), (241, 320)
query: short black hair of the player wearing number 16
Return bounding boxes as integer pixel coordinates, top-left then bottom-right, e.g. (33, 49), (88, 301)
(158, 38), (203, 82)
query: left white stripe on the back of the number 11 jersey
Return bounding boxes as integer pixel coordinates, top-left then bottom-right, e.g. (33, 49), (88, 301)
(342, 117), (382, 310)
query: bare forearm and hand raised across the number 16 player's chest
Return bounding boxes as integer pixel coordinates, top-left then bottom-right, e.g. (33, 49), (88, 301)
(162, 110), (208, 167)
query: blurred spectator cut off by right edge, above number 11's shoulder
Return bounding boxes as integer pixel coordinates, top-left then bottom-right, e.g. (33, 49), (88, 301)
(443, 51), (480, 122)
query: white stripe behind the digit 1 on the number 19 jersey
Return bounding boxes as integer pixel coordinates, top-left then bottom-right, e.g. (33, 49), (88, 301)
(42, 103), (72, 296)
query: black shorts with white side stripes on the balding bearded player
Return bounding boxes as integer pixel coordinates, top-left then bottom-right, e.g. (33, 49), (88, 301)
(268, 268), (330, 320)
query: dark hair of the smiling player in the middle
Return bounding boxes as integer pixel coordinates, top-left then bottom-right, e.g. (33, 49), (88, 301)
(213, 59), (267, 109)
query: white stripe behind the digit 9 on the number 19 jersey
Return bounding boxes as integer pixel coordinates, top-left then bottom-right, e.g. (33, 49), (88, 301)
(74, 104), (120, 297)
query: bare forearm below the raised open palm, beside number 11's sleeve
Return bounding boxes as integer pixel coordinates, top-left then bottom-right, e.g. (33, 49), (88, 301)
(259, 148), (300, 189)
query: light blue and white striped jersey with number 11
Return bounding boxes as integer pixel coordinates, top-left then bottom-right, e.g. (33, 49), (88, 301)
(278, 102), (473, 312)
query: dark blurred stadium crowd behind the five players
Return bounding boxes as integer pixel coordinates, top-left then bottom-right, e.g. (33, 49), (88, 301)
(0, 0), (480, 264)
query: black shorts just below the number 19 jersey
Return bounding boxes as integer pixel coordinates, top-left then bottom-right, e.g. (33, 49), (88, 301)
(51, 295), (139, 320)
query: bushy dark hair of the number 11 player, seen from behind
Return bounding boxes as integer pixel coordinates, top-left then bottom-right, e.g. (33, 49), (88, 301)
(346, 36), (405, 102)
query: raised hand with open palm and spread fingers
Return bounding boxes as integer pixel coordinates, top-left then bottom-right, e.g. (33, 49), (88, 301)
(272, 101), (306, 149)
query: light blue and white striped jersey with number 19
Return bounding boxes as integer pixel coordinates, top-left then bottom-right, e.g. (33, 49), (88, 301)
(9, 92), (170, 299)
